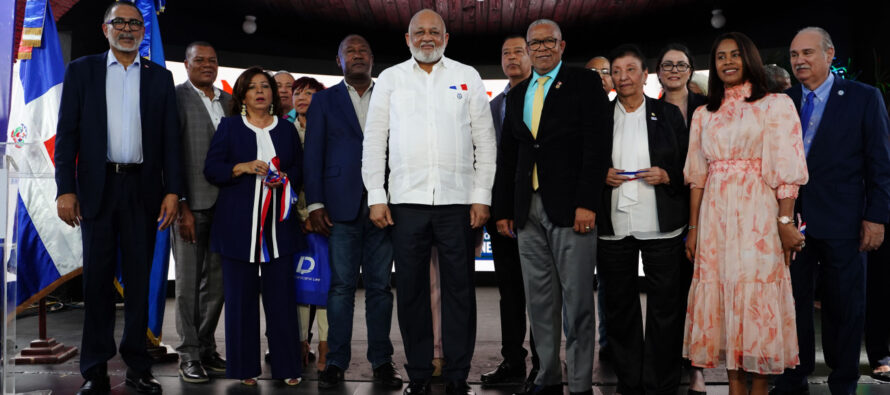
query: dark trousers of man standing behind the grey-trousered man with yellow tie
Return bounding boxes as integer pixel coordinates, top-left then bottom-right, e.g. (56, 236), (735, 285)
(485, 219), (539, 368)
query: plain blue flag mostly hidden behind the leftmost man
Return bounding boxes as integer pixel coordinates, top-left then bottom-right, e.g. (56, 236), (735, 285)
(116, 0), (171, 346)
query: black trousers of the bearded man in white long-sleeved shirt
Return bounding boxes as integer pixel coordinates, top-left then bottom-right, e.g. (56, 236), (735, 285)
(390, 204), (476, 381)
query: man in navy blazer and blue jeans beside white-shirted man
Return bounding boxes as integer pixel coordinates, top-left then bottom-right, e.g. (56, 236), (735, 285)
(303, 35), (402, 389)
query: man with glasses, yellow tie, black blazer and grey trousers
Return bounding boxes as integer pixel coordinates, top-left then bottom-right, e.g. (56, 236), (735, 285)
(493, 19), (611, 395)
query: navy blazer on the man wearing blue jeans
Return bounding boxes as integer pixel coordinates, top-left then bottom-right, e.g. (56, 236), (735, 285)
(303, 82), (370, 222)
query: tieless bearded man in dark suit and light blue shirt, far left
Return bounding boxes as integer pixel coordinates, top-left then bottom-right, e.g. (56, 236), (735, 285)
(55, 2), (182, 394)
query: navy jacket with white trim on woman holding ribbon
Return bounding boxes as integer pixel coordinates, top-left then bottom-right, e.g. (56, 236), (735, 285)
(204, 115), (306, 261)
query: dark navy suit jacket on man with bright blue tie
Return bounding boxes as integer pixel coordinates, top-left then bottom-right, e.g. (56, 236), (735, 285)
(785, 77), (890, 239)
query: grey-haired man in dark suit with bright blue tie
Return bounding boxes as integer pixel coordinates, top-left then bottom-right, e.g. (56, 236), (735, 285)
(774, 27), (890, 394)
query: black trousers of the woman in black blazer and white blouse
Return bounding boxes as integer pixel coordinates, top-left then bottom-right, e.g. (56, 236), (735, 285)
(591, 236), (684, 395)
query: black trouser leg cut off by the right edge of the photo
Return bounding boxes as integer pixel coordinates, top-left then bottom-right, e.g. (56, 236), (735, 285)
(865, 242), (890, 369)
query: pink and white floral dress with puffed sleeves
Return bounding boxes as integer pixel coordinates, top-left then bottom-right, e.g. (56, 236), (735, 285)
(683, 83), (808, 374)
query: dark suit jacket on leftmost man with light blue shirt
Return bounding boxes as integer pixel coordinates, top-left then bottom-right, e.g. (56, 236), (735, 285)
(54, 52), (182, 219)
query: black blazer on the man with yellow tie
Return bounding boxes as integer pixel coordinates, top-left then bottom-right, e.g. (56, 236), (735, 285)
(493, 64), (612, 228)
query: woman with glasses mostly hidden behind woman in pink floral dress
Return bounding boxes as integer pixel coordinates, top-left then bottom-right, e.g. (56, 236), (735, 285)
(655, 43), (708, 395)
